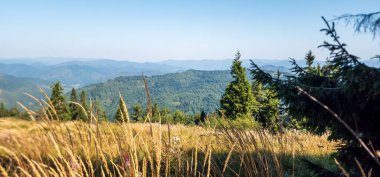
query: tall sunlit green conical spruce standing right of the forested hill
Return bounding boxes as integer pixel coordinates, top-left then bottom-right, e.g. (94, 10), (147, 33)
(220, 52), (255, 119)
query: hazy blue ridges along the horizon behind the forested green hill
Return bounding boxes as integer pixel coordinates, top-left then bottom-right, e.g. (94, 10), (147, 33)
(0, 58), (289, 89)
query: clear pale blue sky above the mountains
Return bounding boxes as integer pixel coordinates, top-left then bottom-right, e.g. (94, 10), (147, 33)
(0, 0), (380, 61)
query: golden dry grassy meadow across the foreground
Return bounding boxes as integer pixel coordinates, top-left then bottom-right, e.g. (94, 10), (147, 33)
(0, 118), (337, 177)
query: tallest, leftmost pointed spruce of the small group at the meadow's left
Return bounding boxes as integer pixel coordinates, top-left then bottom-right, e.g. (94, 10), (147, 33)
(50, 81), (70, 120)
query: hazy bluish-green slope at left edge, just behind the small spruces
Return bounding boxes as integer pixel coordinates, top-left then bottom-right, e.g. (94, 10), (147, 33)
(0, 74), (50, 107)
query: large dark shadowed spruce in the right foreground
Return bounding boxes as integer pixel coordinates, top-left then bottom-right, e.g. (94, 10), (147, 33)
(251, 17), (380, 176)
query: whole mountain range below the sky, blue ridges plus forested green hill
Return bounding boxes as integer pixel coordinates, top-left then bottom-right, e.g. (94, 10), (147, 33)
(0, 58), (380, 112)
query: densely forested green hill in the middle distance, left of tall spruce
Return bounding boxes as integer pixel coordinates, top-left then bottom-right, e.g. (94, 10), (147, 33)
(82, 70), (232, 116)
